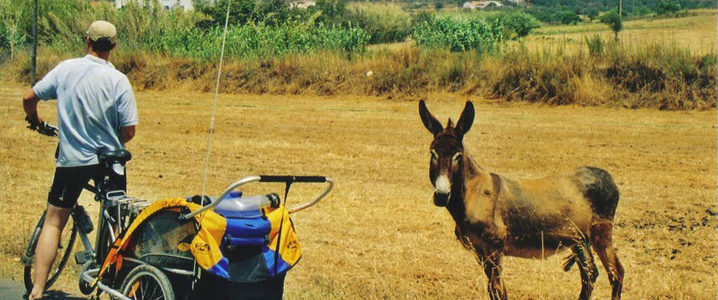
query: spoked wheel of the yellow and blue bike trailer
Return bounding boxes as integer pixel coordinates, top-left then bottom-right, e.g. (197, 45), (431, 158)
(122, 265), (175, 300)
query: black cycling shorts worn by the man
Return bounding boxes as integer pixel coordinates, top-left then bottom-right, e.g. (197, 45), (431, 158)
(47, 165), (102, 208)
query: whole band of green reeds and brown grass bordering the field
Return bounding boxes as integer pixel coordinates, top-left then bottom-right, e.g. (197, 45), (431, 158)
(0, 0), (718, 110)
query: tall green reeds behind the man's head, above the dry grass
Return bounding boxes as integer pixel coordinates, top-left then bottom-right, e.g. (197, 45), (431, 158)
(0, 0), (370, 60)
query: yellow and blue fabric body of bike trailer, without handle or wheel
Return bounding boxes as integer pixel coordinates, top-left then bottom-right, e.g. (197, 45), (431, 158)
(98, 198), (302, 299)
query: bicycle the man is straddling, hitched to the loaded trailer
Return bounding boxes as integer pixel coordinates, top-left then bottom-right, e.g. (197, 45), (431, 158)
(22, 119), (148, 295)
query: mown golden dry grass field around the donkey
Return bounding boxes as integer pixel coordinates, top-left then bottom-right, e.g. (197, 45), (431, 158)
(0, 83), (718, 299)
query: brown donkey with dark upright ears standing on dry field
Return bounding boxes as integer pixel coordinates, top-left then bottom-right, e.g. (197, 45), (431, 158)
(419, 100), (624, 300)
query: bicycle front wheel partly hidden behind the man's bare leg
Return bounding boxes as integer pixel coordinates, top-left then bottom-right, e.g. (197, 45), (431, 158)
(23, 213), (77, 292)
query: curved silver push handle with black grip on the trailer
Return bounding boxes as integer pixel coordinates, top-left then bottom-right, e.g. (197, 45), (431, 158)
(180, 175), (334, 220)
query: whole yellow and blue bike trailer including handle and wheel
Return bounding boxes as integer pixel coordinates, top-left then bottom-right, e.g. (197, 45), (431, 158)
(89, 175), (334, 300)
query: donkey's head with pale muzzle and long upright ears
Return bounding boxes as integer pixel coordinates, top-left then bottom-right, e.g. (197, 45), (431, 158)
(419, 100), (474, 206)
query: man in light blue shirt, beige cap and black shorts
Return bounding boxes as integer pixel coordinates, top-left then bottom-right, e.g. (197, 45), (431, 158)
(23, 21), (137, 300)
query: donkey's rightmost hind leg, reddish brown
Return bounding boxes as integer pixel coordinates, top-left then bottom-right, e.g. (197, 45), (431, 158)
(591, 221), (625, 300)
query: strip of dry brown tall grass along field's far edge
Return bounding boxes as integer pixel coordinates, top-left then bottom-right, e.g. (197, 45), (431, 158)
(2, 34), (718, 110)
